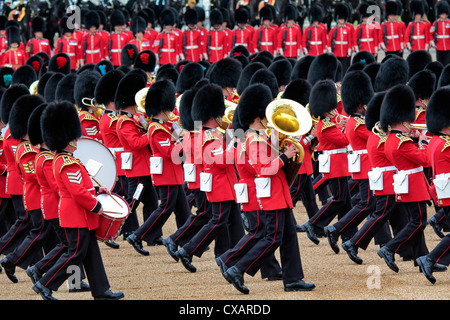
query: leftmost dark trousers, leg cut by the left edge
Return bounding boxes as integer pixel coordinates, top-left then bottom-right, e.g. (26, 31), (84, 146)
(0, 195), (31, 255)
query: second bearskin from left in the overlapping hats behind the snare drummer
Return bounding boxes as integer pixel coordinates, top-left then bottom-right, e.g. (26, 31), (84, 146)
(9, 94), (45, 140)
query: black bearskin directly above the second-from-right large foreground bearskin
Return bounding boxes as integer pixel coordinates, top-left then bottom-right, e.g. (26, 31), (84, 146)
(374, 57), (409, 92)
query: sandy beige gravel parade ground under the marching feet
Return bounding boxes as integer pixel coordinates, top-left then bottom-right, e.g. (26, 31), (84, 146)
(0, 203), (450, 301)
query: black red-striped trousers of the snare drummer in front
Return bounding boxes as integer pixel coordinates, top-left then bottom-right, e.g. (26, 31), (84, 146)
(39, 228), (110, 297)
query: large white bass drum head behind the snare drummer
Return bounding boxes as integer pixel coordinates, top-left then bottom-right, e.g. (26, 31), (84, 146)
(73, 138), (117, 190)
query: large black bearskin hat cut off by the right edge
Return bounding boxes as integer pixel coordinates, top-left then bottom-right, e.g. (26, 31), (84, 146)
(425, 87), (450, 135)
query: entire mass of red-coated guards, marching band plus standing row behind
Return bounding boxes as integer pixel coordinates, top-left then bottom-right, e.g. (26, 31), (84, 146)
(0, 0), (450, 300)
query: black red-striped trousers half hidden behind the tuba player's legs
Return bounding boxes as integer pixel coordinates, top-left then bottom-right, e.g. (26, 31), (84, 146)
(220, 211), (281, 279)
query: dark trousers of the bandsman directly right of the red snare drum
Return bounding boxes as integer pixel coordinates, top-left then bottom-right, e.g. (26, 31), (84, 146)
(122, 176), (158, 234)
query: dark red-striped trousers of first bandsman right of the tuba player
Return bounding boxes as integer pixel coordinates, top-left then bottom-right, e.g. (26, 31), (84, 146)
(309, 177), (352, 234)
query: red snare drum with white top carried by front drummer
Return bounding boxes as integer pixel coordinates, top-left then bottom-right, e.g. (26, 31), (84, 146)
(95, 193), (130, 241)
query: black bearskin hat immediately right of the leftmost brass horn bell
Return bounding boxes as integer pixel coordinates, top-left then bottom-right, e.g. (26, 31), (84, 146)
(145, 80), (176, 116)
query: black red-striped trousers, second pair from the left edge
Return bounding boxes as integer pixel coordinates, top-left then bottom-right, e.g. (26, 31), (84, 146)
(6, 209), (46, 269)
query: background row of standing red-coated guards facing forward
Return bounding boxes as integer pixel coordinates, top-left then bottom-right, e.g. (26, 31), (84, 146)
(0, 0), (450, 73)
